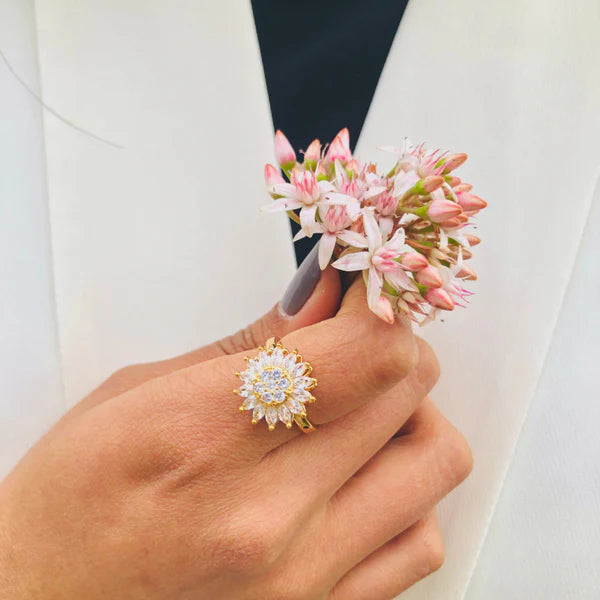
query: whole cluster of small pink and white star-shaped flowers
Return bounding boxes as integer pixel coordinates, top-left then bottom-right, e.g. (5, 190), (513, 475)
(263, 129), (487, 324)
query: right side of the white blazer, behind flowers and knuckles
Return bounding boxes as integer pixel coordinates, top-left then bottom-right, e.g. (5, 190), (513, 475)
(358, 0), (600, 600)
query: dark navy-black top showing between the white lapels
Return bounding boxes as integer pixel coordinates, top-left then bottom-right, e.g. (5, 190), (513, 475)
(252, 0), (408, 263)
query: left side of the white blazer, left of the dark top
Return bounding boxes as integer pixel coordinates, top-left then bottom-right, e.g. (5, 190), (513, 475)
(0, 0), (294, 475)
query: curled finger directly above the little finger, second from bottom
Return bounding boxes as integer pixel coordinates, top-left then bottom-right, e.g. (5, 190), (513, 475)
(314, 399), (472, 575)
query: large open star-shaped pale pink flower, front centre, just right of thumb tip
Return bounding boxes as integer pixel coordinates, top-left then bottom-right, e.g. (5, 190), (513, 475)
(333, 207), (418, 310)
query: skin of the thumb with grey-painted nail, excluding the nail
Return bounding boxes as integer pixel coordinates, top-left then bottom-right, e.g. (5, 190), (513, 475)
(61, 268), (340, 418)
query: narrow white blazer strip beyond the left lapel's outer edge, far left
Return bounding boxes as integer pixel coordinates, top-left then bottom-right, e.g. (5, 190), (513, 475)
(0, 0), (64, 478)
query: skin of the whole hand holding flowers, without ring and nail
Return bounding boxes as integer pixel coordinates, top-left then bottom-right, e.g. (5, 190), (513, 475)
(0, 270), (472, 600)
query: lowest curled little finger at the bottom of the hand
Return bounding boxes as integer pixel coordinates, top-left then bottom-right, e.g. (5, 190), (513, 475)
(328, 511), (444, 600)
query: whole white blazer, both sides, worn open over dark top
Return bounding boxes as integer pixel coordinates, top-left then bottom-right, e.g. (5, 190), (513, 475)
(0, 0), (600, 600)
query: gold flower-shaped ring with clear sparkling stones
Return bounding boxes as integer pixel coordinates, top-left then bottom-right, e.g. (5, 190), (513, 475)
(233, 338), (317, 433)
